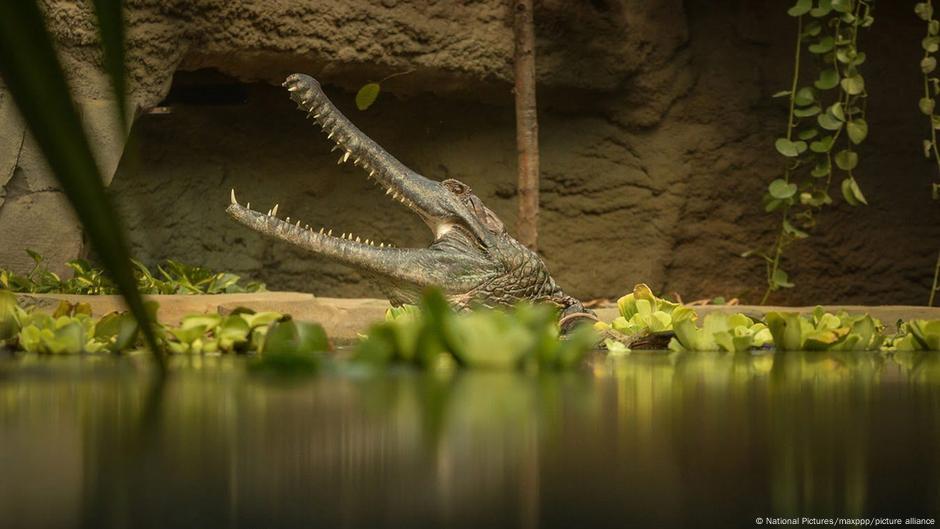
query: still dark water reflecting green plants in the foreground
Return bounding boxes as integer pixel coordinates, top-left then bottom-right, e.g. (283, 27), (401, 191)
(0, 353), (940, 528)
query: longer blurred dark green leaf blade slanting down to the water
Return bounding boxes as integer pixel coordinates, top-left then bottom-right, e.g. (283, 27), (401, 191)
(0, 0), (165, 373)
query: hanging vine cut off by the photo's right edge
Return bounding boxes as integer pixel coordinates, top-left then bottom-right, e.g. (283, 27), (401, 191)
(914, 0), (940, 307)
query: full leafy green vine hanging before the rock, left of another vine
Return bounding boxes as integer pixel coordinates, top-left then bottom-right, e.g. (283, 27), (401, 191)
(744, 0), (875, 304)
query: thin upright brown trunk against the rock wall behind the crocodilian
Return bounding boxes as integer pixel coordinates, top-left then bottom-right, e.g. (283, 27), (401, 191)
(512, 0), (539, 250)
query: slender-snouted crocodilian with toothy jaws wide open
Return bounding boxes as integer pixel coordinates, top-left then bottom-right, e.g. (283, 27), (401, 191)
(226, 74), (585, 318)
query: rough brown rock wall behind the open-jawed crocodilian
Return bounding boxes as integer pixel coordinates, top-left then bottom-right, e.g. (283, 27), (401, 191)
(0, 0), (940, 303)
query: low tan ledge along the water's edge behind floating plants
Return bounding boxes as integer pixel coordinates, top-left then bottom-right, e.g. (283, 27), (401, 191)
(17, 292), (940, 343)
